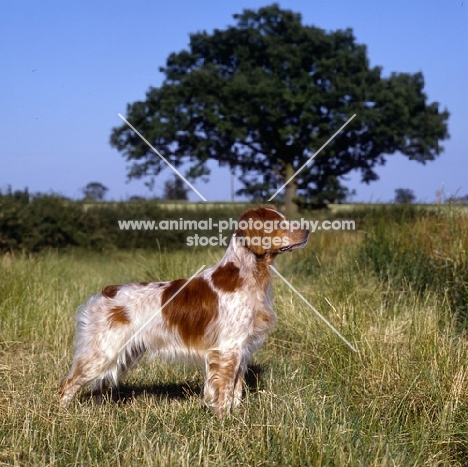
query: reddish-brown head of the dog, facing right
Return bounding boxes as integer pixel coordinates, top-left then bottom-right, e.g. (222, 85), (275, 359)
(235, 206), (309, 256)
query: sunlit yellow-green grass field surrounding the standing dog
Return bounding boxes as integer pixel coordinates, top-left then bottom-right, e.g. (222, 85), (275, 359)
(0, 209), (468, 467)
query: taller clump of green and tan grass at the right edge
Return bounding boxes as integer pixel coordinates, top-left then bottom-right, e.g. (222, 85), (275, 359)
(359, 206), (468, 325)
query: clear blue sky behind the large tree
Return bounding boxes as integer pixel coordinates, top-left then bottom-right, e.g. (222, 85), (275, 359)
(0, 0), (468, 202)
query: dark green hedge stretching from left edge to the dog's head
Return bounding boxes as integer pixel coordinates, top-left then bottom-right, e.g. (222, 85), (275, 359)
(0, 192), (242, 252)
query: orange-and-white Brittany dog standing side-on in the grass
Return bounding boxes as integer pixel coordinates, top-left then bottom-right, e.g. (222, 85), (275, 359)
(60, 207), (309, 417)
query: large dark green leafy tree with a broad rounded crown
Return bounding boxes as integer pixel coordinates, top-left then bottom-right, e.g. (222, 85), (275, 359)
(111, 4), (448, 212)
